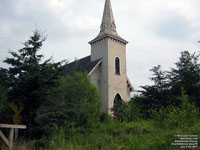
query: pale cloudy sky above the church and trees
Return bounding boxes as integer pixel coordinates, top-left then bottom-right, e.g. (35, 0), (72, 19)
(0, 0), (200, 91)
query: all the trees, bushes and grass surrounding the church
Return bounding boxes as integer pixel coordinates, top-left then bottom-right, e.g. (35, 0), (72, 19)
(0, 31), (200, 150)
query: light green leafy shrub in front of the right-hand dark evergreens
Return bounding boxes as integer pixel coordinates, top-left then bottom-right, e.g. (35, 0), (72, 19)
(152, 90), (199, 129)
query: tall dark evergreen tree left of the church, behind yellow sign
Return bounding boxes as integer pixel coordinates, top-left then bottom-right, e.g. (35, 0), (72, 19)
(4, 30), (62, 137)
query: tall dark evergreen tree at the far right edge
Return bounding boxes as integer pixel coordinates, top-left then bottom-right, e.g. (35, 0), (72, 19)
(168, 51), (200, 108)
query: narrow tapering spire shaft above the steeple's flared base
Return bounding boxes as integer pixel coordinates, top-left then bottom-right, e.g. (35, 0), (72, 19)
(100, 0), (116, 32)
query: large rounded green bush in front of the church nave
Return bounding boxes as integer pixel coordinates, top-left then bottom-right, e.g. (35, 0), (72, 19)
(36, 73), (101, 133)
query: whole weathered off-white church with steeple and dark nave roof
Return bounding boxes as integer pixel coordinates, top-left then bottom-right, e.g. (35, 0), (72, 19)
(63, 0), (133, 112)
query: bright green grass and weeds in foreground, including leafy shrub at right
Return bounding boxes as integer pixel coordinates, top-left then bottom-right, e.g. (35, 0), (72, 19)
(7, 94), (200, 150)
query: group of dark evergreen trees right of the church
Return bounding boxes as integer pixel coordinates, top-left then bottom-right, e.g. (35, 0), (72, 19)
(137, 51), (200, 117)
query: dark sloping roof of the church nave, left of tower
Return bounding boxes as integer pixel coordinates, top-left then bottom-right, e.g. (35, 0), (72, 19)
(63, 55), (102, 75)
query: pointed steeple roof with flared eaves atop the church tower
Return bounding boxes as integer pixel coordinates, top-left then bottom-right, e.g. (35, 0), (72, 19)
(89, 0), (128, 44)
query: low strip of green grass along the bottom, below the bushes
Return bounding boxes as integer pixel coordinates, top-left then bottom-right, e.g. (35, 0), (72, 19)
(1, 120), (200, 150)
